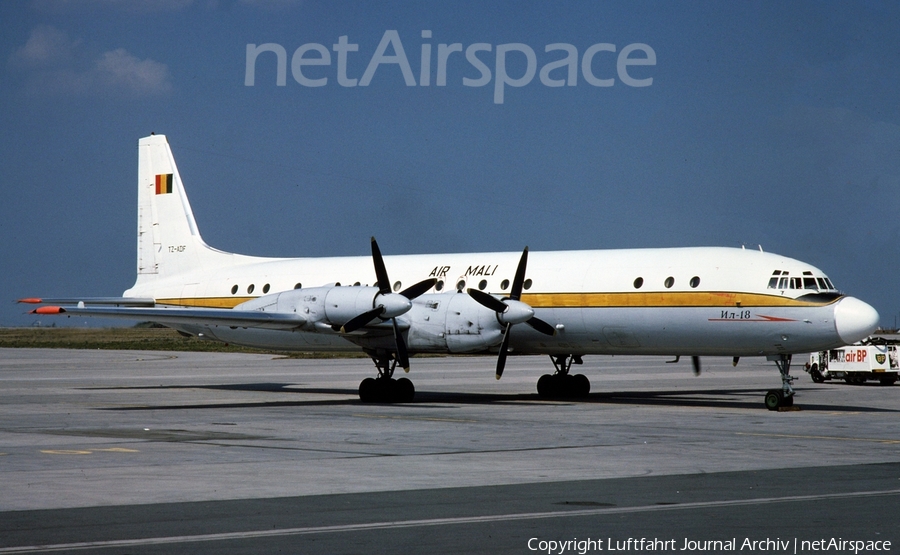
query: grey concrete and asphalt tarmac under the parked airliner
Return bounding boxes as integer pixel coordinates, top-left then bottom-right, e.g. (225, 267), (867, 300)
(0, 349), (900, 555)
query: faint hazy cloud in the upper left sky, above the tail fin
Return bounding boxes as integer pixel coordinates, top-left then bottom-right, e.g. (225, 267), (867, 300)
(9, 26), (172, 96)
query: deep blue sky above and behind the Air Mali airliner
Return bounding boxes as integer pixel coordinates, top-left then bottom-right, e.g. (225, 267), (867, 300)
(0, 0), (900, 326)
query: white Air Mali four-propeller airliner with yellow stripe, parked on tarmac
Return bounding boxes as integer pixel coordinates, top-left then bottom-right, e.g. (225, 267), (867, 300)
(23, 135), (878, 410)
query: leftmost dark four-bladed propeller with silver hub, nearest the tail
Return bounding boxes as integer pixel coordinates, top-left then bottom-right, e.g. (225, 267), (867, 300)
(341, 237), (437, 372)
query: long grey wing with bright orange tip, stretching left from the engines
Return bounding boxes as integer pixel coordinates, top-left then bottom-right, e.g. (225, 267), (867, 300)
(25, 299), (306, 330)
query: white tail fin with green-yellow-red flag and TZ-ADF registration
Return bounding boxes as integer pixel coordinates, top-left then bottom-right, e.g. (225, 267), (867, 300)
(136, 135), (232, 285)
